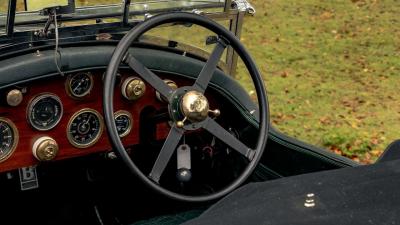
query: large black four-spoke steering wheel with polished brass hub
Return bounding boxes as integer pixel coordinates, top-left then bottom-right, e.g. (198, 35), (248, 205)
(103, 12), (269, 202)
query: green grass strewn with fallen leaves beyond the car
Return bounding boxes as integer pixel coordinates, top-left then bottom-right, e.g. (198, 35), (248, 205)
(0, 0), (400, 163)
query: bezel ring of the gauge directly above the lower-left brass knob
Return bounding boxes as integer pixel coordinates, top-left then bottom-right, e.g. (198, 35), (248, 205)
(26, 92), (64, 131)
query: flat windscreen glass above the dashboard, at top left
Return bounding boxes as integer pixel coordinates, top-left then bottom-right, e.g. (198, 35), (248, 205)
(0, 0), (225, 30)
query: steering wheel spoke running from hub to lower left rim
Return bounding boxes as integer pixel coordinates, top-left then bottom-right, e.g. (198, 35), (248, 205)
(149, 125), (184, 183)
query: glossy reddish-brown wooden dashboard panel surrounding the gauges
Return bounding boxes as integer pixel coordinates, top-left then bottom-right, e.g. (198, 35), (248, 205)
(0, 70), (179, 172)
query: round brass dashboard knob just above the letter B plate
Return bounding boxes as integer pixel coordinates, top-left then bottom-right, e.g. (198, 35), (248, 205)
(32, 136), (58, 161)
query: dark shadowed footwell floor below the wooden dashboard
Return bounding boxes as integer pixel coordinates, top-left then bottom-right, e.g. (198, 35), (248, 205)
(0, 154), (204, 225)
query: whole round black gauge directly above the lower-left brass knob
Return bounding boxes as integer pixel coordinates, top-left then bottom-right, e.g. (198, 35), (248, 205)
(27, 94), (63, 131)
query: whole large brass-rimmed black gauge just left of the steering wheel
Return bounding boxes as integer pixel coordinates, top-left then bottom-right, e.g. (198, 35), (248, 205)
(67, 109), (104, 148)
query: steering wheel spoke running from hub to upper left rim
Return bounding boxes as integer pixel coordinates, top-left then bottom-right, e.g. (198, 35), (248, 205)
(124, 53), (173, 101)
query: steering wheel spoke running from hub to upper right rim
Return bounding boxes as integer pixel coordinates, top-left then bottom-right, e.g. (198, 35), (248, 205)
(193, 38), (228, 94)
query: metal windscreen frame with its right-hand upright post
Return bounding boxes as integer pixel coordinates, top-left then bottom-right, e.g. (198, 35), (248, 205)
(0, 0), (250, 76)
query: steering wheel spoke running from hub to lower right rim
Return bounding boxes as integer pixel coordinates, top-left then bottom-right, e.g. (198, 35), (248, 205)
(203, 117), (255, 161)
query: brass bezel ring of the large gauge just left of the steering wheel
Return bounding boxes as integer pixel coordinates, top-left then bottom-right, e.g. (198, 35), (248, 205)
(67, 108), (104, 148)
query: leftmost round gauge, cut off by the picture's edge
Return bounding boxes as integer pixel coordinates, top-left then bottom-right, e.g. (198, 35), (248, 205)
(0, 118), (18, 162)
